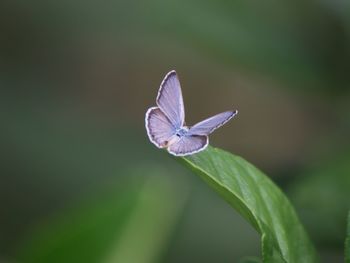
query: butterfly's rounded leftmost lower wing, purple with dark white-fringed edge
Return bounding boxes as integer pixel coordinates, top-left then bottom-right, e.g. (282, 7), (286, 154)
(146, 107), (176, 148)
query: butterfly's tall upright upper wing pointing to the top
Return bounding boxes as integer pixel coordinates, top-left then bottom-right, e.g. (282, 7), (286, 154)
(157, 70), (185, 128)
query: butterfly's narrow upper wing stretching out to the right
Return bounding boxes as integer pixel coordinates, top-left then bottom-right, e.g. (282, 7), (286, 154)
(188, 111), (238, 136)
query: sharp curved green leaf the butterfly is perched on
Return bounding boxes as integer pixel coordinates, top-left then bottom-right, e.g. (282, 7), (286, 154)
(180, 146), (318, 262)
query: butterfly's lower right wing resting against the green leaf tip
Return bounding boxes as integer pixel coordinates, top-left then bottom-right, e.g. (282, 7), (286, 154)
(168, 135), (209, 156)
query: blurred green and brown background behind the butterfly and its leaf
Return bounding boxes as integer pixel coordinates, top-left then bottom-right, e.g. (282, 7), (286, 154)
(0, 0), (350, 263)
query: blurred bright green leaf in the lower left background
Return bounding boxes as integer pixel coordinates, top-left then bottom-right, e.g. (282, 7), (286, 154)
(18, 173), (185, 263)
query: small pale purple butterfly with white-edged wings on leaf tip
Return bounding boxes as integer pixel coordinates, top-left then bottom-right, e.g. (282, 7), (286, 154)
(145, 70), (238, 156)
